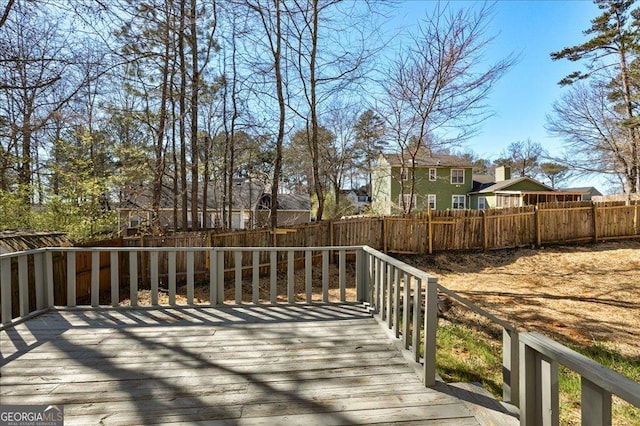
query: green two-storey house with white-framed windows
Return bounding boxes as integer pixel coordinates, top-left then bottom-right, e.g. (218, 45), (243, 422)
(371, 152), (473, 215)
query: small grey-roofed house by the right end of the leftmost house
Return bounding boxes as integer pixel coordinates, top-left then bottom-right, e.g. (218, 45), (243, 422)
(256, 193), (311, 228)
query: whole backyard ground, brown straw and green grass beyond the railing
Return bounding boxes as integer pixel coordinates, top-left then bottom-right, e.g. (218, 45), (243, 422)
(402, 241), (640, 425)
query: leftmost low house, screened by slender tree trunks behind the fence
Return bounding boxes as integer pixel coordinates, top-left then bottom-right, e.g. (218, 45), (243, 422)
(116, 179), (264, 235)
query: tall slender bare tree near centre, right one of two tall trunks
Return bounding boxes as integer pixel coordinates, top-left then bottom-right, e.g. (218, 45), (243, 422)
(287, 0), (375, 220)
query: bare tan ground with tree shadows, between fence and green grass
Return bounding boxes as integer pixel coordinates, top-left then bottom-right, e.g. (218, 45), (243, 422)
(403, 241), (640, 362)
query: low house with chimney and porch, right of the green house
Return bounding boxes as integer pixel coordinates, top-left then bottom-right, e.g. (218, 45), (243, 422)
(469, 166), (583, 210)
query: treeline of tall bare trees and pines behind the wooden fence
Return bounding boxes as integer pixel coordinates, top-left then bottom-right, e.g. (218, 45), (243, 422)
(0, 0), (640, 241)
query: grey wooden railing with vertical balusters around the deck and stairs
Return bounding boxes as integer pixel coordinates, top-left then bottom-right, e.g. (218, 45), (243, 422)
(0, 246), (640, 425)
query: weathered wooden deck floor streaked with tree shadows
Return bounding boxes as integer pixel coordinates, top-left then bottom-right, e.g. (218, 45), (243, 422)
(0, 304), (517, 426)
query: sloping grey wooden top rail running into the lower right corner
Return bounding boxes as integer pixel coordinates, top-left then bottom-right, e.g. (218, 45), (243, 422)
(520, 332), (640, 407)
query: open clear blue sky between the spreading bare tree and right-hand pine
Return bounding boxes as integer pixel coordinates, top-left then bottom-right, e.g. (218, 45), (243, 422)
(392, 0), (607, 191)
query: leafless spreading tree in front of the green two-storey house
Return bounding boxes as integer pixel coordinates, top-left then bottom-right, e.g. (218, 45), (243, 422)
(380, 3), (515, 213)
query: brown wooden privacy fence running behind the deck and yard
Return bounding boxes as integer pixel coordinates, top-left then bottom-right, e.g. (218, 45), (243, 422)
(117, 202), (640, 281)
